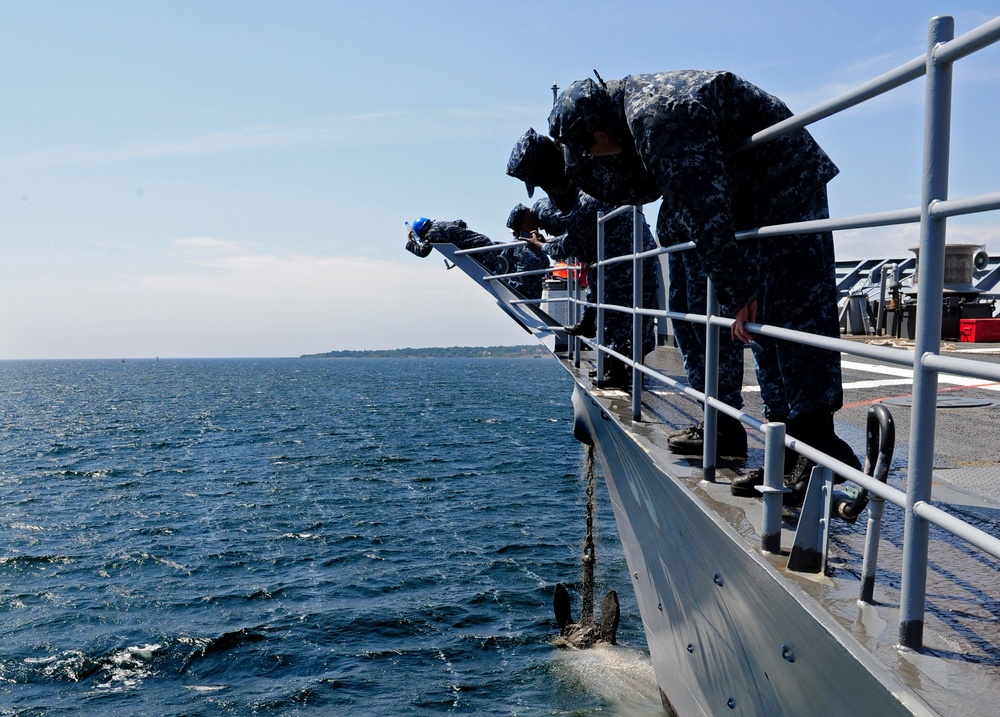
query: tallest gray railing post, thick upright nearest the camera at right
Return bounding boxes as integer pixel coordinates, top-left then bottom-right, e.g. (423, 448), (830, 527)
(899, 16), (955, 650)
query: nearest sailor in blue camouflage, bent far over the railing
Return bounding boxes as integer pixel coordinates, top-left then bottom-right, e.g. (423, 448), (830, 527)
(549, 70), (860, 491)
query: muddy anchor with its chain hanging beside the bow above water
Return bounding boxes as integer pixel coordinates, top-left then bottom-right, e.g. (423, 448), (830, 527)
(552, 445), (621, 649)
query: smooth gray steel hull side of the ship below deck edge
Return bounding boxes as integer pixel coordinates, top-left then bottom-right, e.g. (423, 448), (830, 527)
(573, 382), (936, 717)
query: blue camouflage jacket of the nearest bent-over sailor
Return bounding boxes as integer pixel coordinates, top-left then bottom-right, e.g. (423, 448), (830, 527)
(567, 70), (838, 307)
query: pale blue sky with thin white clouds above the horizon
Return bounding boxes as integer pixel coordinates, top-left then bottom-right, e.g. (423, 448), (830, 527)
(0, 0), (1000, 360)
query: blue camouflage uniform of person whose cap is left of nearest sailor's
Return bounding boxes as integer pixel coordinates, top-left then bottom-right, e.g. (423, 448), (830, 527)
(533, 192), (659, 357)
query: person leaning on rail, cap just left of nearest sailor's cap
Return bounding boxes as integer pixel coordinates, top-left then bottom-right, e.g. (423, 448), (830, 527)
(507, 139), (659, 388)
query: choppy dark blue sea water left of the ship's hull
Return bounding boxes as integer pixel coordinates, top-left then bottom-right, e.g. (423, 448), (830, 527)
(0, 359), (660, 715)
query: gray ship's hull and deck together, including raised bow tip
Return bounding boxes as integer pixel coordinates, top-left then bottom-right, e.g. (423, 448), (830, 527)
(426, 239), (1000, 717)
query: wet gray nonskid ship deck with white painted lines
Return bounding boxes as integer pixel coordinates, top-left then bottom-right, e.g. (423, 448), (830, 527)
(563, 344), (1000, 715)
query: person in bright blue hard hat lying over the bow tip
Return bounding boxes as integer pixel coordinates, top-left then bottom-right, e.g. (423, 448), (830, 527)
(406, 217), (549, 299)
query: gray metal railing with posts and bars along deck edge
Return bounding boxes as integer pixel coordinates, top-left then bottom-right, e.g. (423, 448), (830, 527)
(556, 12), (1000, 649)
